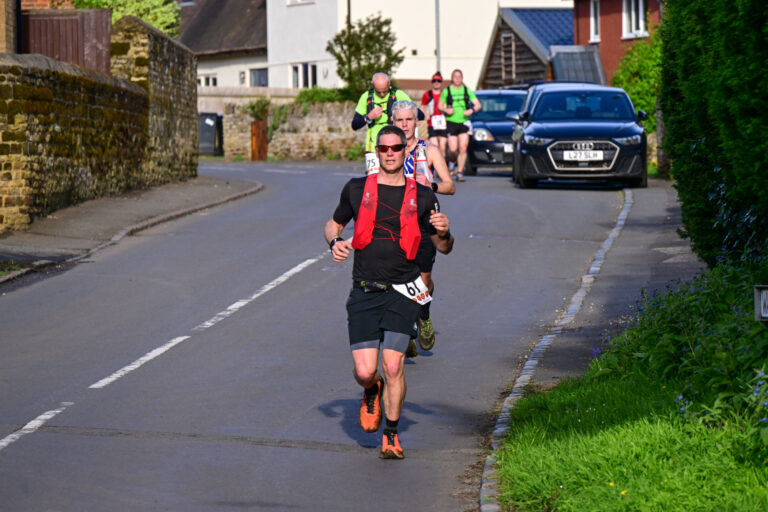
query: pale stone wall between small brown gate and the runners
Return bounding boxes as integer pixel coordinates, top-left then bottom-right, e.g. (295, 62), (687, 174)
(268, 101), (365, 160)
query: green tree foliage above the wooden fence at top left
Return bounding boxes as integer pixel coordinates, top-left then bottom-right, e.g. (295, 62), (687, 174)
(72, 0), (179, 37)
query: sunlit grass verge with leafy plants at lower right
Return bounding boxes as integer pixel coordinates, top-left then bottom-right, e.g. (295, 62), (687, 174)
(497, 263), (768, 511)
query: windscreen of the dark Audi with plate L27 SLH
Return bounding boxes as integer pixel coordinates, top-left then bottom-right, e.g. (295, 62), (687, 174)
(531, 91), (636, 121)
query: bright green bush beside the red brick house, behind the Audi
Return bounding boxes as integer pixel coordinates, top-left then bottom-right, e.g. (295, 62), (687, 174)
(613, 30), (661, 133)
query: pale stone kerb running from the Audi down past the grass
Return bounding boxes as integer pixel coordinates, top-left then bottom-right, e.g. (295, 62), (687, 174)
(480, 189), (634, 512)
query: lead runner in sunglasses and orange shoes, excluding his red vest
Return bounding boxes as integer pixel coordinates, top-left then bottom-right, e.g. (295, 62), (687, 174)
(325, 125), (453, 459)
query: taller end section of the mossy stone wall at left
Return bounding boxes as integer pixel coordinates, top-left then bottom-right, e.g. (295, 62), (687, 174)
(111, 16), (198, 184)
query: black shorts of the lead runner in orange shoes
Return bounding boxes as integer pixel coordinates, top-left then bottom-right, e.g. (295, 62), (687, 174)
(347, 286), (421, 345)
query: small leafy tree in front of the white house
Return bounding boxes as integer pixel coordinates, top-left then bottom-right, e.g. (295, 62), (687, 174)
(325, 14), (405, 96)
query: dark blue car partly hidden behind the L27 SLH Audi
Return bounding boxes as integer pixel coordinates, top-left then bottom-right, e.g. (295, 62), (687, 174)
(464, 89), (526, 174)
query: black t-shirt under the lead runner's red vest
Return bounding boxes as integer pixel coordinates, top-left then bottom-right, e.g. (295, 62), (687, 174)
(333, 177), (440, 284)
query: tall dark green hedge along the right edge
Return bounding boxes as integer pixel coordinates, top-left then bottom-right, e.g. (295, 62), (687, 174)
(661, 0), (768, 266)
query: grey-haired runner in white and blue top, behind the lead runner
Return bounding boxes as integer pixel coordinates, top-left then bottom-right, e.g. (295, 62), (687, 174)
(392, 101), (456, 357)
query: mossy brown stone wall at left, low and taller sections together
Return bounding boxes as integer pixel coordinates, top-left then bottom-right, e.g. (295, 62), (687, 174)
(0, 17), (198, 232)
